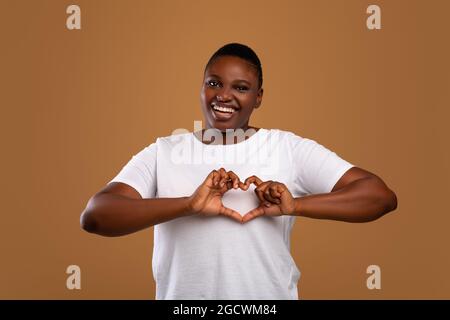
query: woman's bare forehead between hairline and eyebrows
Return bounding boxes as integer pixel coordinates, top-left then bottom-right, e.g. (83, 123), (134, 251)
(206, 56), (257, 80)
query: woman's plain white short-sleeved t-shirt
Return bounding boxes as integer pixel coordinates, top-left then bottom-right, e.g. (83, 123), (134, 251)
(110, 128), (353, 300)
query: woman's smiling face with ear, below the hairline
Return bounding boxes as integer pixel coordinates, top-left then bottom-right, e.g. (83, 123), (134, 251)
(200, 56), (263, 132)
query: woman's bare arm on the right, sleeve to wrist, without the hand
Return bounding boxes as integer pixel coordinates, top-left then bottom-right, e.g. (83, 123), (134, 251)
(294, 167), (397, 222)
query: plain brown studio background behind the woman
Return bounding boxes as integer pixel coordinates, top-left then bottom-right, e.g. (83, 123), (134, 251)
(0, 0), (450, 299)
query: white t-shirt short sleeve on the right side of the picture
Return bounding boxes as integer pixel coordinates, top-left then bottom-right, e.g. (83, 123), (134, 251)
(293, 136), (354, 194)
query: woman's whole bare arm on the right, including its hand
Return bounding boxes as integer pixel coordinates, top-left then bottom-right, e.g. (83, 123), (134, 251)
(242, 167), (397, 222)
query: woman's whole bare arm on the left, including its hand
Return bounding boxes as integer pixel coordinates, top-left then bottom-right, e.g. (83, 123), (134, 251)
(80, 168), (242, 237)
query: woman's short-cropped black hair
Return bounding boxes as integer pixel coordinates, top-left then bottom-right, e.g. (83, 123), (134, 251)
(204, 42), (262, 89)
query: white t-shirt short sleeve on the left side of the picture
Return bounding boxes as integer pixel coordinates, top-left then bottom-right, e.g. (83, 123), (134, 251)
(108, 143), (157, 199)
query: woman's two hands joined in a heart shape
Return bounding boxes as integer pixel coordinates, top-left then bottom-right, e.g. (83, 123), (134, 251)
(189, 168), (295, 223)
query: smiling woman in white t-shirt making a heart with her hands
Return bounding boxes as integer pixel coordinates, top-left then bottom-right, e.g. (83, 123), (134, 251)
(81, 43), (397, 299)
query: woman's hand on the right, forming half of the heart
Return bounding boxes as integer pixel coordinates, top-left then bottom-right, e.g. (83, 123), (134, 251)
(241, 176), (295, 222)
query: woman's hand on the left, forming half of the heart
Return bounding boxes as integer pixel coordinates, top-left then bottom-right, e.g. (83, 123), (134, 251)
(189, 168), (244, 222)
